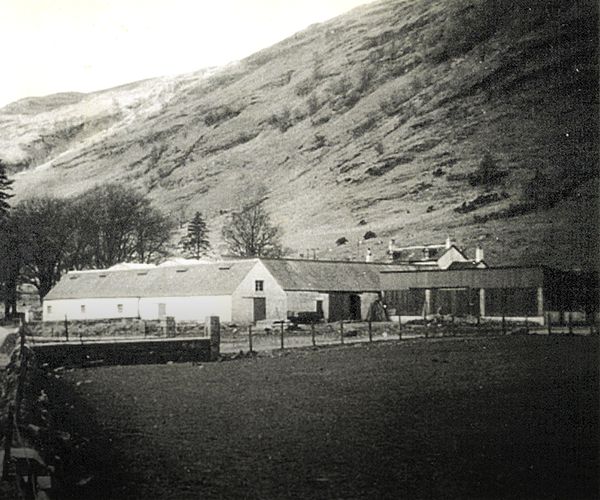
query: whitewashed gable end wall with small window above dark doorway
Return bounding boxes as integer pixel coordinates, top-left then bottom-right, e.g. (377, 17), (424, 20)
(231, 261), (287, 323)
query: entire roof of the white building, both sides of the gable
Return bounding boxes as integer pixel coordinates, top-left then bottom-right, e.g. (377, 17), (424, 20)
(45, 258), (406, 300)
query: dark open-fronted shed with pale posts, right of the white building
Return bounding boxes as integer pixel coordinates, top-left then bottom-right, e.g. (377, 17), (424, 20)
(381, 263), (598, 323)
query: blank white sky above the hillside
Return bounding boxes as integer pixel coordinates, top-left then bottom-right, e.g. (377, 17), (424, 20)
(0, 0), (372, 106)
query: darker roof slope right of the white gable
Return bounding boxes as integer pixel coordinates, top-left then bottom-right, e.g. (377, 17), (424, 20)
(261, 259), (404, 292)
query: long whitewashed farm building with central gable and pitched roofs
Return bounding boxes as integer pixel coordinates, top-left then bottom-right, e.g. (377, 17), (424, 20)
(43, 258), (389, 323)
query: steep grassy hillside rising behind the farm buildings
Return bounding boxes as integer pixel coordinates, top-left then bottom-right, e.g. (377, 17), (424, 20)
(0, 0), (598, 267)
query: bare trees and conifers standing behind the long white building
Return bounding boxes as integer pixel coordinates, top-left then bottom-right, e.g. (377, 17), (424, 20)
(0, 162), (282, 317)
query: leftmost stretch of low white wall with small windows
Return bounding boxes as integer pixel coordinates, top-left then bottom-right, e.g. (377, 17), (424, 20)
(43, 297), (139, 321)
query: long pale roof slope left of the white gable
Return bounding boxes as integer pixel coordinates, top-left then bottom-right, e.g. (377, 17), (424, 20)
(44, 259), (258, 300)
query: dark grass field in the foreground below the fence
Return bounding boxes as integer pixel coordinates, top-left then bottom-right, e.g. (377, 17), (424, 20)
(48, 336), (598, 499)
